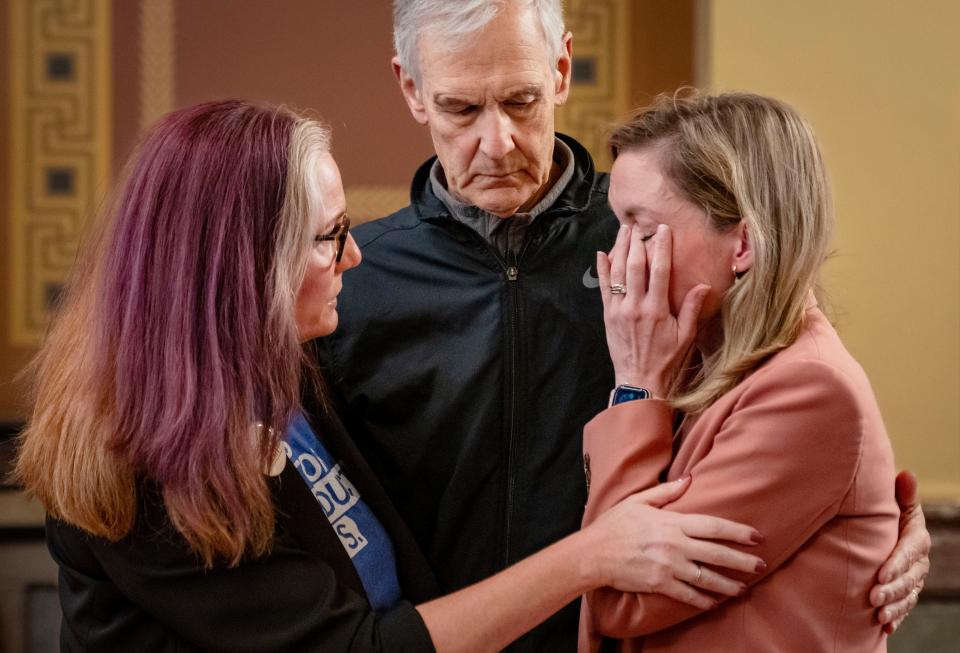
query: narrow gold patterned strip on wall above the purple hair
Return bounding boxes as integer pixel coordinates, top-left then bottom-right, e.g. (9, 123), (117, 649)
(140, 0), (175, 129)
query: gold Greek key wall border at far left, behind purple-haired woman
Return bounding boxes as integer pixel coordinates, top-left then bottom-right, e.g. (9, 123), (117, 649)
(8, 0), (111, 347)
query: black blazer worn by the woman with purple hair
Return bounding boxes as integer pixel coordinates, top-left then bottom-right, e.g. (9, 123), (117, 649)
(47, 400), (436, 653)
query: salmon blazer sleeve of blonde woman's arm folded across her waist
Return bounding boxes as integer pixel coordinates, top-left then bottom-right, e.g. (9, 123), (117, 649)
(587, 360), (863, 637)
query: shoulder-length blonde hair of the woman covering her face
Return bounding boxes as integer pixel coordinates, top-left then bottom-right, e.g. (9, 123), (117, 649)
(610, 92), (833, 413)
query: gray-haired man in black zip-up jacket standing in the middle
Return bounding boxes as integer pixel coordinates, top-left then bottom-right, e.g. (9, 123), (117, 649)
(326, 0), (929, 651)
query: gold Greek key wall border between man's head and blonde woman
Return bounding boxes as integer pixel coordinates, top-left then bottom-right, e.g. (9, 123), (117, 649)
(557, 0), (630, 170)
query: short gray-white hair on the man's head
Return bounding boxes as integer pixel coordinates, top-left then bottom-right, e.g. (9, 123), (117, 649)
(393, 0), (564, 88)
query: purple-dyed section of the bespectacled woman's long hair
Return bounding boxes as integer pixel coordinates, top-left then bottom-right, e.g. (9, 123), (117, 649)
(100, 102), (296, 476)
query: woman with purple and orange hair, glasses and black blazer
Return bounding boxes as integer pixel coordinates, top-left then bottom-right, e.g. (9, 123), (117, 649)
(16, 101), (758, 652)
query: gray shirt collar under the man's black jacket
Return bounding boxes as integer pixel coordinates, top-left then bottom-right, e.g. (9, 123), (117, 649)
(430, 138), (575, 256)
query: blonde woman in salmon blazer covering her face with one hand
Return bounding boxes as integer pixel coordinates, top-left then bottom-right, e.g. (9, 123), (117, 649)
(580, 94), (900, 652)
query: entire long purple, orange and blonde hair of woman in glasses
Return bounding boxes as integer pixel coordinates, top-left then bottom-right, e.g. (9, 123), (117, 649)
(15, 100), (329, 566)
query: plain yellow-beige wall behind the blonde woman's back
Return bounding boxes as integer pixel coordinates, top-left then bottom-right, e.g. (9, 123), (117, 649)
(701, 0), (960, 499)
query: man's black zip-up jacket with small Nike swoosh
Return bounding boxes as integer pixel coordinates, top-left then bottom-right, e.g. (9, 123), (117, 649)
(326, 136), (617, 652)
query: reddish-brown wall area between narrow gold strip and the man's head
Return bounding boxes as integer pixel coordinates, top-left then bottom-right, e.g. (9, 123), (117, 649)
(175, 0), (433, 188)
